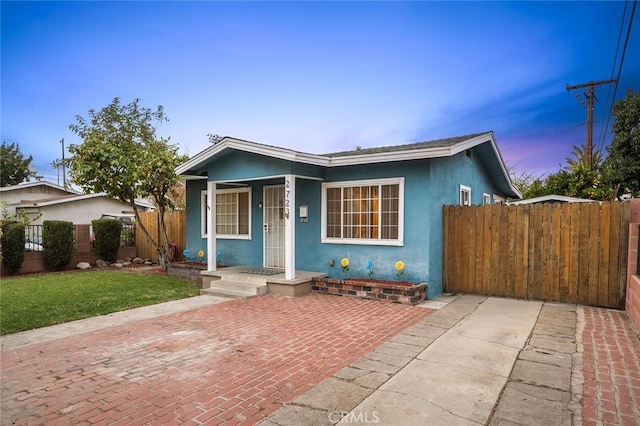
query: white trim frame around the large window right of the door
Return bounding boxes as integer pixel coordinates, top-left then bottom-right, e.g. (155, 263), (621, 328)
(321, 177), (404, 246)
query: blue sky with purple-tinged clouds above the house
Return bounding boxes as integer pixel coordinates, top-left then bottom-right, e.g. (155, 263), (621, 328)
(1, 1), (640, 182)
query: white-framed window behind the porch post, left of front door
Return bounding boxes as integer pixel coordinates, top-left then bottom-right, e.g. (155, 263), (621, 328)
(201, 188), (251, 239)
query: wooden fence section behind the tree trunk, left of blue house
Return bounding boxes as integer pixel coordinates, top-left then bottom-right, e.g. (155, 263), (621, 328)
(136, 210), (187, 263)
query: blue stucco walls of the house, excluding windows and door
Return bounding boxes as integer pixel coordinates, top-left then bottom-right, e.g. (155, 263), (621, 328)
(187, 141), (510, 297)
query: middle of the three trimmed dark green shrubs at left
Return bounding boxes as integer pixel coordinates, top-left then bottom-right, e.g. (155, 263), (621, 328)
(42, 220), (74, 271)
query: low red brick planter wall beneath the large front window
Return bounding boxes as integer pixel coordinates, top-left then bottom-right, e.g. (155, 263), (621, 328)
(311, 278), (427, 305)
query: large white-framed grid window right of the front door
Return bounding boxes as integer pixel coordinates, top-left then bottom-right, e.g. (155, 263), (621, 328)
(322, 178), (404, 245)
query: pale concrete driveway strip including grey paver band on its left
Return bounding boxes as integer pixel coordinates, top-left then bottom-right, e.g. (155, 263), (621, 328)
(261, 296), (542, 426)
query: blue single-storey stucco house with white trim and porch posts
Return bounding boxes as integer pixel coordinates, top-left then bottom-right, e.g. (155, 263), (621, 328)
(177, 132), (521, 297)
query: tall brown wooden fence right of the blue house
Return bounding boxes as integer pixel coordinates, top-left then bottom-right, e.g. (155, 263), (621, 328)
(443, 202), (629, 309)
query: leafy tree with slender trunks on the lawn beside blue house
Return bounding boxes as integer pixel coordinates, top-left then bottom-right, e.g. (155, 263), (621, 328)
(67, 98), (187, 269)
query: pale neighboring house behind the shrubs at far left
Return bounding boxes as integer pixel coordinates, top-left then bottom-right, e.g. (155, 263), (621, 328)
(0, 182), (153, 225)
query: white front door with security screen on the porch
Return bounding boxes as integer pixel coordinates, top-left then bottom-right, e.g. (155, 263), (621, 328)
(262, 185), (284, 269)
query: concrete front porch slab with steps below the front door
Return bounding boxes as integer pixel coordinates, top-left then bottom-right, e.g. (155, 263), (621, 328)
(200, 266), (327, 298)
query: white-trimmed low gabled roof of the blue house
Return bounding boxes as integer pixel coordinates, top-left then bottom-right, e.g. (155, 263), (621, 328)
(176, 132), (522, 198)
